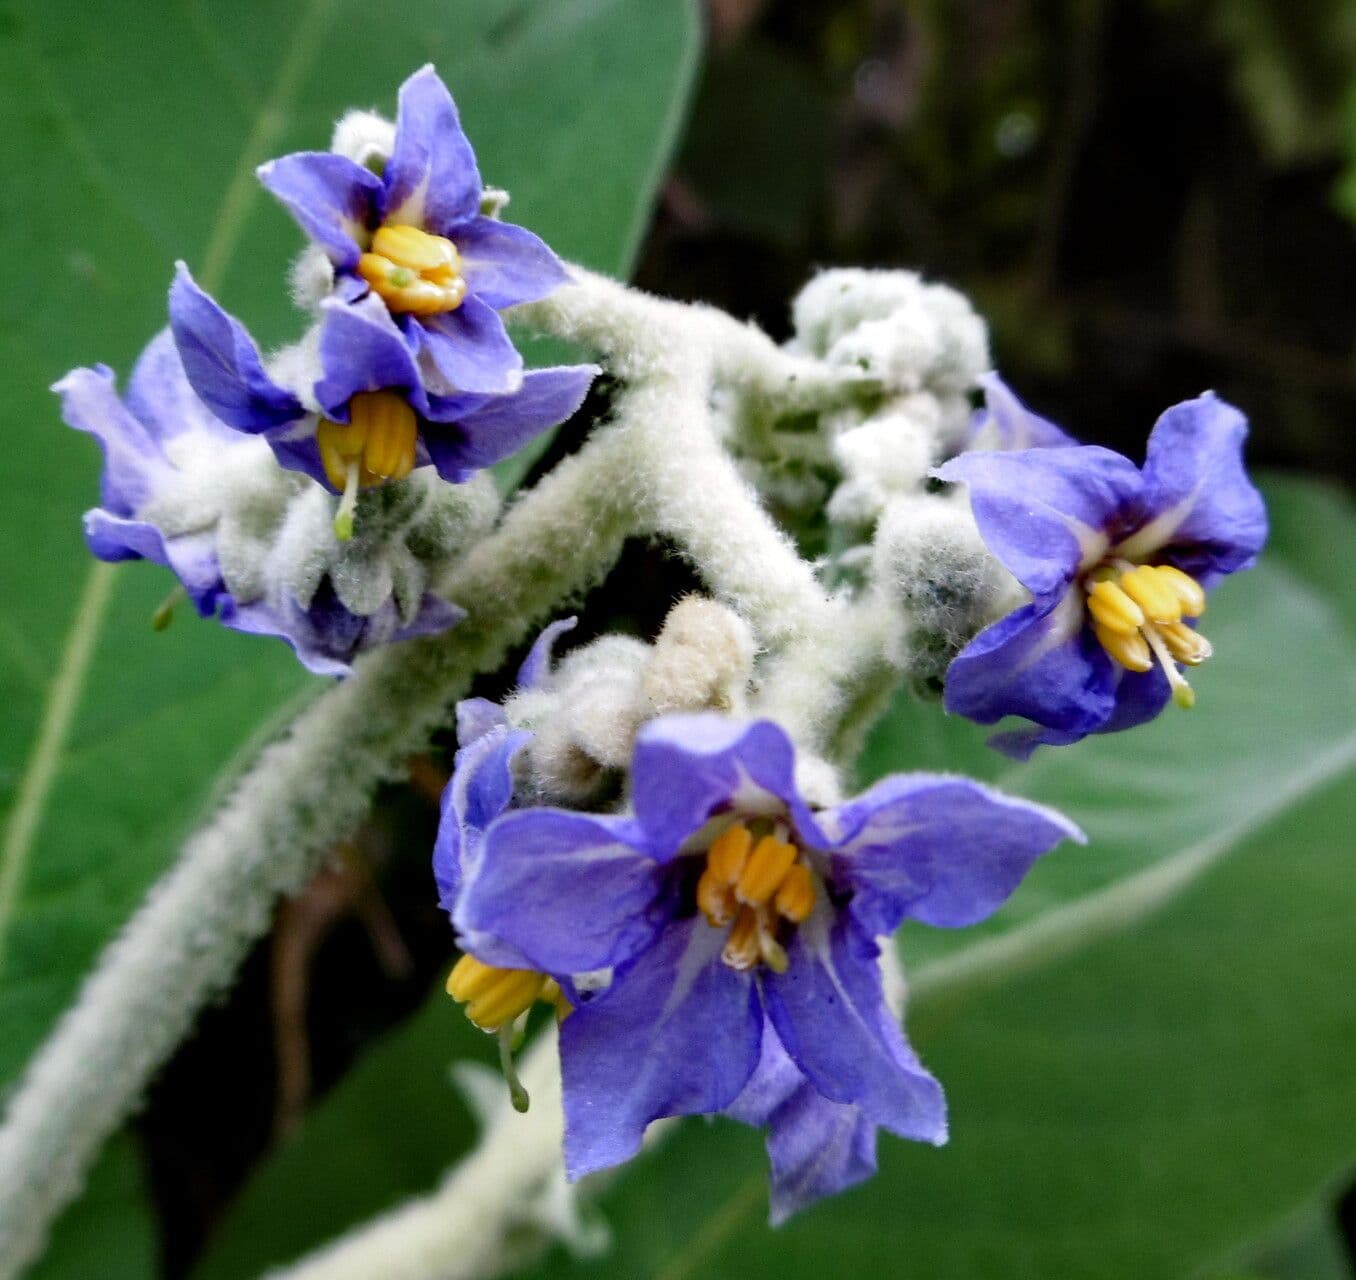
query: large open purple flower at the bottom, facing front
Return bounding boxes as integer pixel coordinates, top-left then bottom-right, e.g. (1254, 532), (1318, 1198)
(454, 715), (1082, 1214)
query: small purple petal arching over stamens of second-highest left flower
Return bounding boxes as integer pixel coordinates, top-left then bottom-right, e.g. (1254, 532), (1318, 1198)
(315, 296), (428, 422)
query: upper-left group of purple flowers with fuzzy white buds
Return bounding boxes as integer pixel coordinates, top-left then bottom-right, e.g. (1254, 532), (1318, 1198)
(56, 68), (598, 675)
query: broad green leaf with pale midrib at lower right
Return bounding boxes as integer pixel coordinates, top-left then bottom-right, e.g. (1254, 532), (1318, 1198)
(509, 474), (1356, 1280)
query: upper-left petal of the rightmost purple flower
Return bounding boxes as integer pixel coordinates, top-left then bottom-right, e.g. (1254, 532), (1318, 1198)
(933, 445), (1143, 595)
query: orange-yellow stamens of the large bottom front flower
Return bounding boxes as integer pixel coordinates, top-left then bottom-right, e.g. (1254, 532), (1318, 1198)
(697, 822), (816, 974)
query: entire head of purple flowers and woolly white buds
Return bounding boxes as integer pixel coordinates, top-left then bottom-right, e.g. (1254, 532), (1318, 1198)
(56, 68), (1267, 1242)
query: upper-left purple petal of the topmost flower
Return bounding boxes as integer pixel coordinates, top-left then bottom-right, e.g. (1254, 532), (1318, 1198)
(255, 151), (384, 271)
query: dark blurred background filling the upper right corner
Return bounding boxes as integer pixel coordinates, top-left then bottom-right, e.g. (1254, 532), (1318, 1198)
(639, 0), (1356, 483)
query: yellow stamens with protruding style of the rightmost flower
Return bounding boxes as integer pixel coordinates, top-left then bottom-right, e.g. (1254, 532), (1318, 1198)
(1083, 560), (1214, 706)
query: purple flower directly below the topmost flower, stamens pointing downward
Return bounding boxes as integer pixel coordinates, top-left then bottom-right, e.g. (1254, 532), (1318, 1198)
(170, 264), (598, 526)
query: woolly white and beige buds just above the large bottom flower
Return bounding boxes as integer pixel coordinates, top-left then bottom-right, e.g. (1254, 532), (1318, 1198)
(504, 595), (754, 803)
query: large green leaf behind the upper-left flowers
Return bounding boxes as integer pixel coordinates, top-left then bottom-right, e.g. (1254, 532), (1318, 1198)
(0, 0), (696, 1258)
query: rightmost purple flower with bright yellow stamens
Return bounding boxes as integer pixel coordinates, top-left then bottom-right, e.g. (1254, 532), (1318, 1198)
(934, 384), (1267, 758)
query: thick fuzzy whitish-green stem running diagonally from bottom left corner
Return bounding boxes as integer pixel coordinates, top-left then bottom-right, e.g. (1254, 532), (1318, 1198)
(0, 423), (635, 1280)
